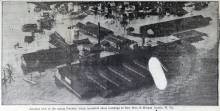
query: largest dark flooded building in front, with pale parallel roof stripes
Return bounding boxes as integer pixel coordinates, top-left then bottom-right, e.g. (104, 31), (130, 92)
(55, 38), (198, 99)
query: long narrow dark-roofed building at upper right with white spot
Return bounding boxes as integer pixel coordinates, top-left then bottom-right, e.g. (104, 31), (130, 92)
(140, 15), (211, 37)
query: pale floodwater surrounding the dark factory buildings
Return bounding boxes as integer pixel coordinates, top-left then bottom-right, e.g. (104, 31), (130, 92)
(2, 2), (218, 105)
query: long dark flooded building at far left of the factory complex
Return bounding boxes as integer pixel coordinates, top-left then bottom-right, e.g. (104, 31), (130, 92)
(21, 45), (79, 74)
